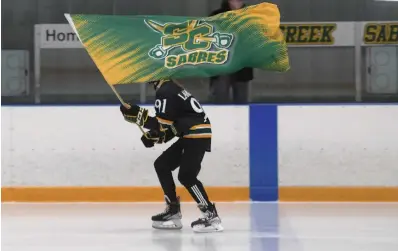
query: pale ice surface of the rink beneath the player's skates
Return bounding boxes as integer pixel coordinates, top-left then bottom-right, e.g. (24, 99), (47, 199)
(1, 203), (398, 251)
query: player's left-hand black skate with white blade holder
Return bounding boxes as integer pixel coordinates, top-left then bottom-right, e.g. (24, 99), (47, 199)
(152, 196), (182, 230)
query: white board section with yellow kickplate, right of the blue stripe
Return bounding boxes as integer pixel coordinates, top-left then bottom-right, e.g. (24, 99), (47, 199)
(278, 105), (398, 201)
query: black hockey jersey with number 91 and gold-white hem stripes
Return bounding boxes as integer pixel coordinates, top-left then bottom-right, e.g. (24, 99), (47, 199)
(145, 80), (212, 138)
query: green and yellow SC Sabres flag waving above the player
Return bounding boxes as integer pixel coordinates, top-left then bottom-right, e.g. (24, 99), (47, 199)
(65, 3), (290, 85)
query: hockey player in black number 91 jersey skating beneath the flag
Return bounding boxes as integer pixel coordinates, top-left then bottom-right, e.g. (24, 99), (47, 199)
(120, 80), (223, 232)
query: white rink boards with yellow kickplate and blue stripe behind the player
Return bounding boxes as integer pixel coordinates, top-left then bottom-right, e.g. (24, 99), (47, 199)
(1, 104), (398, 202)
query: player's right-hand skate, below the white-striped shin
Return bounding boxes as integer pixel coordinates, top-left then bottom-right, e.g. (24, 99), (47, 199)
(191, 204), (224, 233)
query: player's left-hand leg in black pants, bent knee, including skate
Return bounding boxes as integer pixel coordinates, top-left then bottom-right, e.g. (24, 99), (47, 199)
(152, 139), (183, 229)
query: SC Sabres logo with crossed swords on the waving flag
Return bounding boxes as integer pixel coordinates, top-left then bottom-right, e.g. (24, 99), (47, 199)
(145, 20), (234, 69)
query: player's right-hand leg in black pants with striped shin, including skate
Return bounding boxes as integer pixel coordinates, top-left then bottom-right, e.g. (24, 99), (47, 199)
(178, 139), (223, 232)
